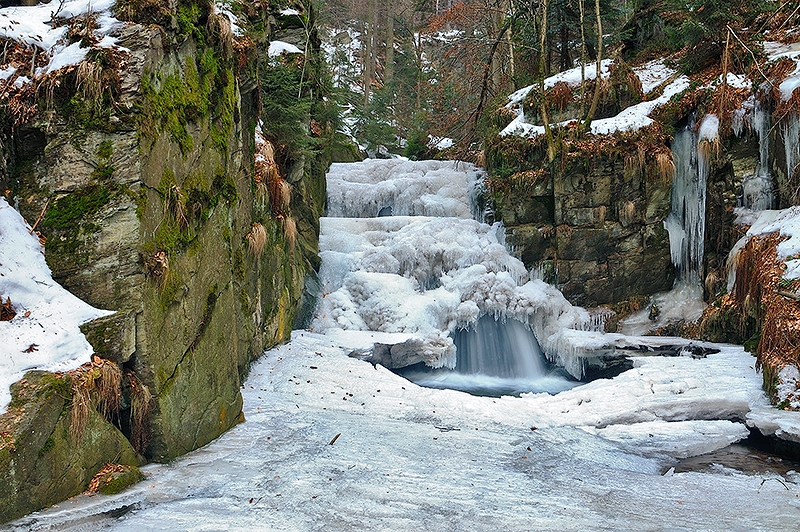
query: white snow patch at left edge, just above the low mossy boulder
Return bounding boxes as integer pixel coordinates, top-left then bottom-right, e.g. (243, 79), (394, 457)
(0, 198), (111, 412)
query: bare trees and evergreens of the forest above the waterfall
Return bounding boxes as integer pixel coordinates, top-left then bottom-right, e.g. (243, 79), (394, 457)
(319, 0), (800, 157)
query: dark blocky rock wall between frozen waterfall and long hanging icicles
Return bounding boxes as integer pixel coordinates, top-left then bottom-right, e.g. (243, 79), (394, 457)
(487, 135), (674, 307)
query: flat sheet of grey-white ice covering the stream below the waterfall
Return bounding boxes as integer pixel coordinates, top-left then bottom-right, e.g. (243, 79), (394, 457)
(10, 332), (800, 531)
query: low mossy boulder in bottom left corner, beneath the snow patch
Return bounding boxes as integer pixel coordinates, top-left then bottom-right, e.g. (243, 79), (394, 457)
(0, 372), (139, 522)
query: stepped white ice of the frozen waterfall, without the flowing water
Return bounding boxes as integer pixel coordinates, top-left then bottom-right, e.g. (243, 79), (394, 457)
(312, 159), (591, 389)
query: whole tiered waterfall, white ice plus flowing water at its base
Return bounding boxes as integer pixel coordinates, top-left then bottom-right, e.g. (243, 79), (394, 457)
(312, 159), (591, 395)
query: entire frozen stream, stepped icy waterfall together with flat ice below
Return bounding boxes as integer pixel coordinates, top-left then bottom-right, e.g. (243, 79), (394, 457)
(9, 160), (800, 531)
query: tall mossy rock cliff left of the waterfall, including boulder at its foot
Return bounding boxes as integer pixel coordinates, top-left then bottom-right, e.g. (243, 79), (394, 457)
(0, 0), (335, 520)
